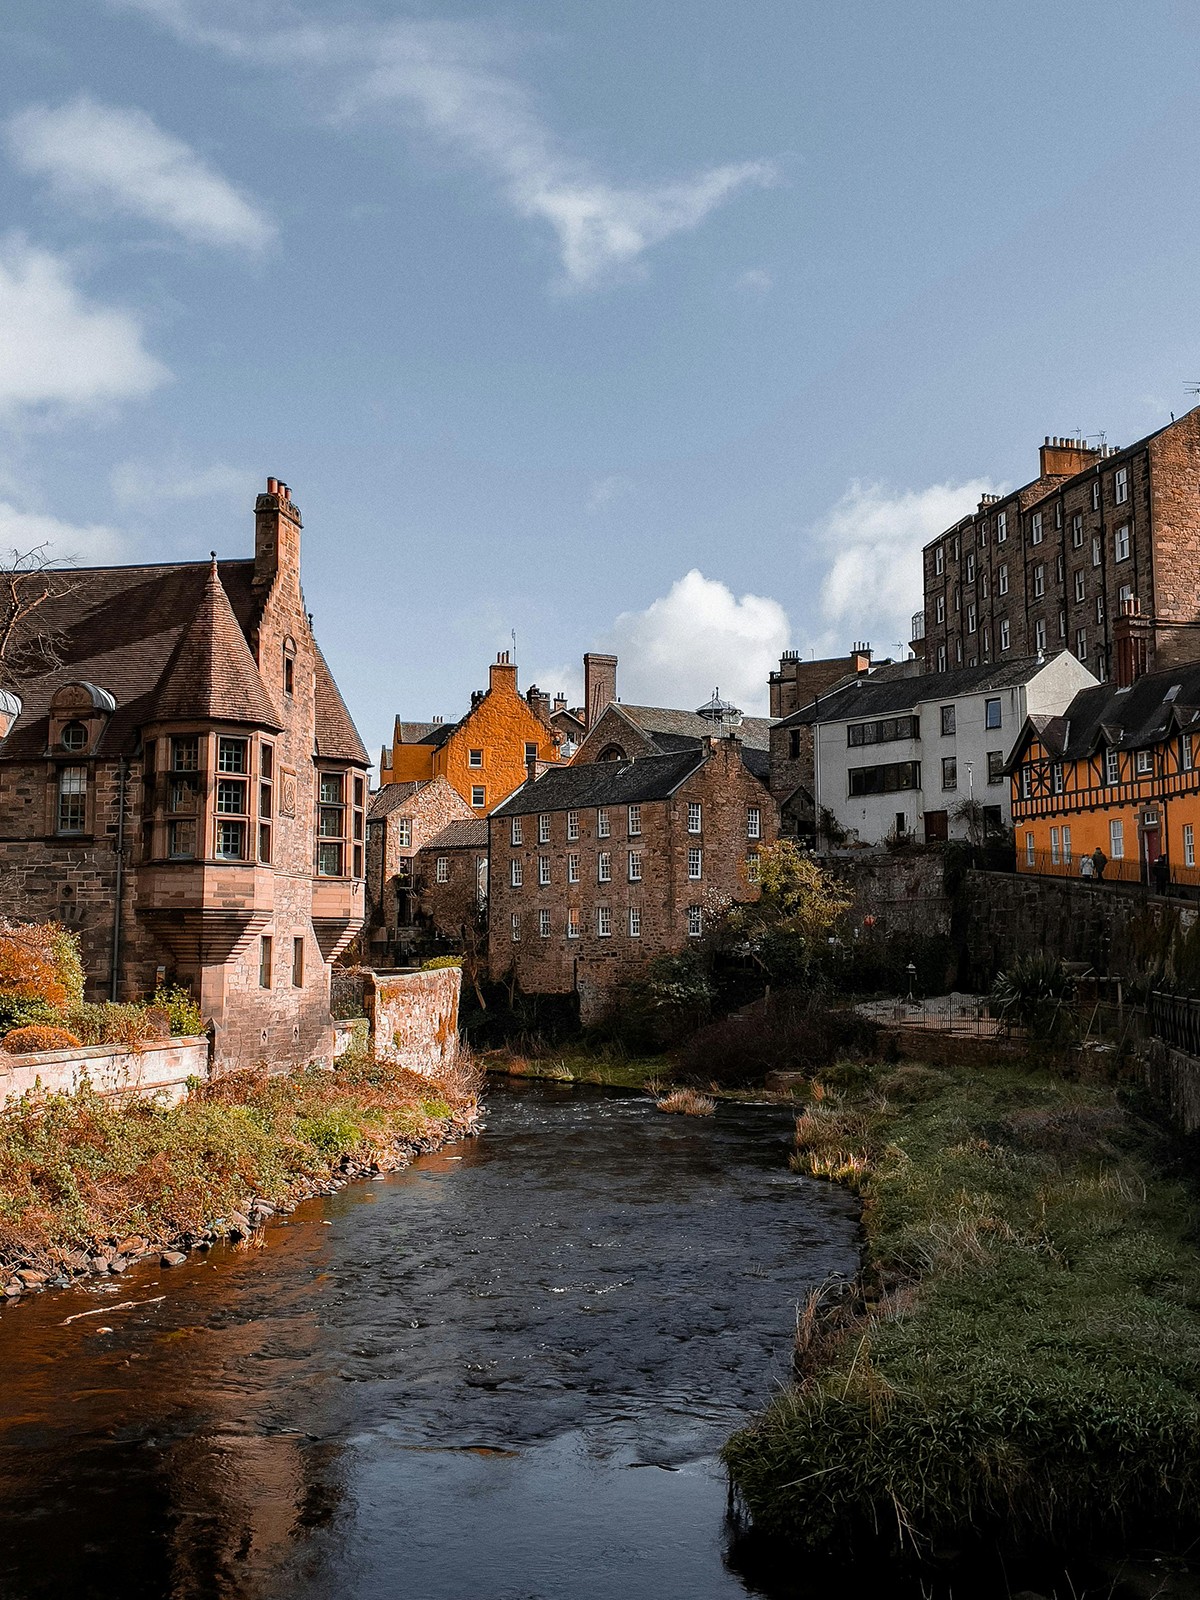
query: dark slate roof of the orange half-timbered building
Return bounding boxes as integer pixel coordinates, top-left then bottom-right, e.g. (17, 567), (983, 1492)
(1010, 662), (1200, 762)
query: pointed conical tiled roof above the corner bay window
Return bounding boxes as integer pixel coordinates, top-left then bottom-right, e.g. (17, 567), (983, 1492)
(154, 557), (283, 733)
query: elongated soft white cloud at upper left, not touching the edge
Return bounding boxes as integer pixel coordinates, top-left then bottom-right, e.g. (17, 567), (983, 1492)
(5, 94), (275, 250)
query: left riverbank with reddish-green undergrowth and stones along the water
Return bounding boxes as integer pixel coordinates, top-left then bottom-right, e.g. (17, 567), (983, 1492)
(0, 1053), (478, 1302)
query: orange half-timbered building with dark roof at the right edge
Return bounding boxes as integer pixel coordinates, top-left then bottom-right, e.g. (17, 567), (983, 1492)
(1008, 662), (1200, 890)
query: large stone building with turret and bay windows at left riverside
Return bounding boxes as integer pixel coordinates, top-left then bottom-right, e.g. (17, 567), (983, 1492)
(0, 478), (368, 1067)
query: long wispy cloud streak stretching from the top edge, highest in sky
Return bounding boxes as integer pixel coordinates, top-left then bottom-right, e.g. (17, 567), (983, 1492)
(114, 0), (776, 288)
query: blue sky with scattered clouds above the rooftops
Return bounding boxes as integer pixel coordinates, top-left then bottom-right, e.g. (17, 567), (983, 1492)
(0, 0), (1200, 761)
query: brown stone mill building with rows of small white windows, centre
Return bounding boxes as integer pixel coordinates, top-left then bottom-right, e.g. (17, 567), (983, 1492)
(488, 731), (776, 1022)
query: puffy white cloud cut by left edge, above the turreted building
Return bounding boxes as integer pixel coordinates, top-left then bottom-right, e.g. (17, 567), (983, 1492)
(0, 237), (170, 413)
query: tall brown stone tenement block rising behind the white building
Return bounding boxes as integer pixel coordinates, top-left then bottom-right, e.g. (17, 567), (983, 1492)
(923, 408), (1200, 680)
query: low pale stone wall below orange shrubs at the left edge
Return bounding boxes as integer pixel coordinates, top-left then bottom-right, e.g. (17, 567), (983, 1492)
(0, 1038), (208, 1106)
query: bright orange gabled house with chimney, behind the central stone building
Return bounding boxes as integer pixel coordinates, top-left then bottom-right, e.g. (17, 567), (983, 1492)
(379, 650), (562, 816)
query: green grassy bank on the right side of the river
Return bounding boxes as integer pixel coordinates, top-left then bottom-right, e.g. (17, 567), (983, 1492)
(725, 1062), (1200, 1552)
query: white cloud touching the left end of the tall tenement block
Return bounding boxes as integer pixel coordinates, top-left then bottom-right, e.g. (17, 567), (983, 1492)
(811, 478), (998, 656)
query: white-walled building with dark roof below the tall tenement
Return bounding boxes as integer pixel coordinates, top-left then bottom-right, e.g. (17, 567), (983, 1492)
(800, 651), (1098, 845)
